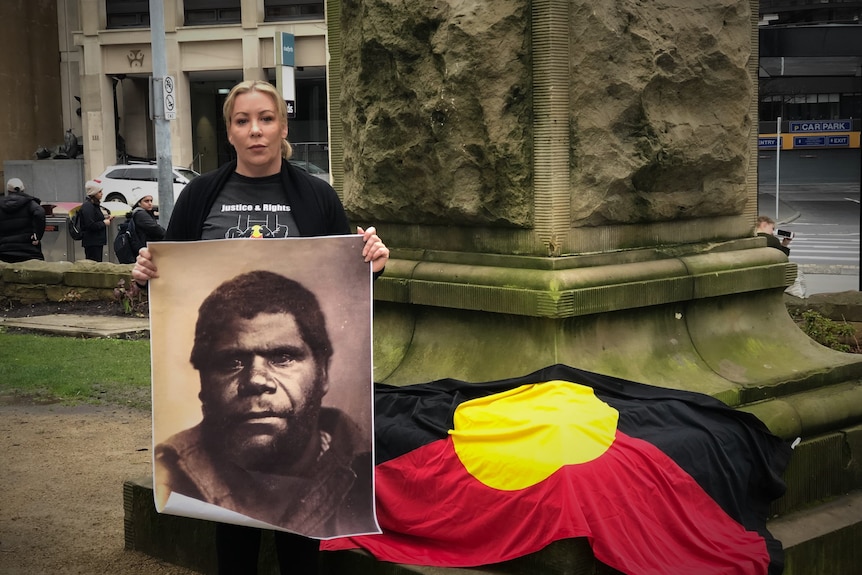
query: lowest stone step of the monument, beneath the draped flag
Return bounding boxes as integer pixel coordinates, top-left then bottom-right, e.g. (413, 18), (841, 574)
(123, 477), (862, 575)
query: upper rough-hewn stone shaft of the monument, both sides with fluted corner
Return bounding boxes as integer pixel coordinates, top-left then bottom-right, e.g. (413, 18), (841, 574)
(338, 0), (756, 228)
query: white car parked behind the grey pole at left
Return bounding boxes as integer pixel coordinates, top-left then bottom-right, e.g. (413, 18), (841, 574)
(93, 163), (200, 206)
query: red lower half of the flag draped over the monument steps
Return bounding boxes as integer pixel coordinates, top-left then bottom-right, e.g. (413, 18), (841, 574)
(321, 432), (770, 575)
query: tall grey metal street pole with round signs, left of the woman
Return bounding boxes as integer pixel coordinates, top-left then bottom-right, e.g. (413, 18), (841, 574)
(150, 0), (174, 223)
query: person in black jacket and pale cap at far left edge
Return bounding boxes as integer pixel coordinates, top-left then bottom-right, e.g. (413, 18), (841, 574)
(0, 178), (45, 263)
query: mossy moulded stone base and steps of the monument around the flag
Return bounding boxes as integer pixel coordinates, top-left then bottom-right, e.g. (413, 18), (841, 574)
(125, 245), (862, 575)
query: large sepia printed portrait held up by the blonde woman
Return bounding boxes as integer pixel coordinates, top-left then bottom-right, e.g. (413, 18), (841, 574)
(149, 235), (380, 539)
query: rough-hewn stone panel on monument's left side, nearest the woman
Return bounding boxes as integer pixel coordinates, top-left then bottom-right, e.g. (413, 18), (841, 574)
(341, 0), (532, 227)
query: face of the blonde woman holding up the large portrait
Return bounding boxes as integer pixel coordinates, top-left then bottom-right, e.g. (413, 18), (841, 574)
(227, 91), (287, 177)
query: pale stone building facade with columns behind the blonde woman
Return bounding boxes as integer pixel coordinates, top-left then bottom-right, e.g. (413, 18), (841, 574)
(66, 0), (329, 182)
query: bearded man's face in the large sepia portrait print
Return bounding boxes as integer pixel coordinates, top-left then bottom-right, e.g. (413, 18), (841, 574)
(199, 312), (328, 473)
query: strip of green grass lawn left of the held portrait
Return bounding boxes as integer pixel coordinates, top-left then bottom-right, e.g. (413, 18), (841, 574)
(0, 330), (151, 409)
